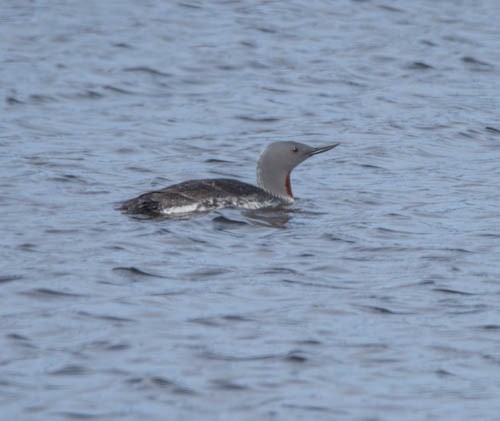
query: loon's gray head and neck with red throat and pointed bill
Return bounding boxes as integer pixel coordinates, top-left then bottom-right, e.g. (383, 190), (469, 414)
(257, 142), (339, 202)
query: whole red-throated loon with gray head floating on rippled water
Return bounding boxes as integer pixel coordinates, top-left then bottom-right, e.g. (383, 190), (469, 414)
(120, 141), (339, 216)
